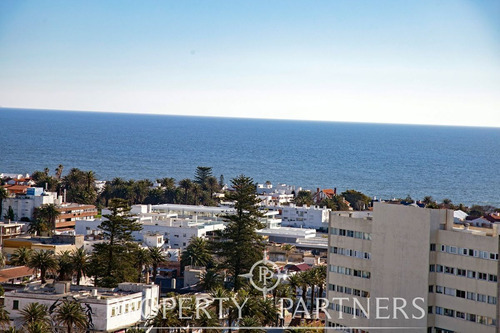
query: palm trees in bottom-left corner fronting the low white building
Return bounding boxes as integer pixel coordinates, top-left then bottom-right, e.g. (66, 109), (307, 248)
(0, 299), (89, 333)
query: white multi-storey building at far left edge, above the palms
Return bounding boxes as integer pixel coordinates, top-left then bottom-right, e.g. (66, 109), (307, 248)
(1, 187), (62, 221)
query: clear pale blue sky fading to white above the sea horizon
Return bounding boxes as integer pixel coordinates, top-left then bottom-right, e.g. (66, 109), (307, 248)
(0, 0), (500, 127)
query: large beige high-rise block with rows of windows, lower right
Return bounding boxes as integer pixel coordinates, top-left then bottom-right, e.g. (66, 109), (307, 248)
(326, 203), (499, 333)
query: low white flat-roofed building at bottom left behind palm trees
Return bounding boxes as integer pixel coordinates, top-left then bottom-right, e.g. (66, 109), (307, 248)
(5, 282), (160, 332)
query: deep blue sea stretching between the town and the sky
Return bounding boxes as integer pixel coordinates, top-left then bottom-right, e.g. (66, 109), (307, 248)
(0, 109), (500, 206)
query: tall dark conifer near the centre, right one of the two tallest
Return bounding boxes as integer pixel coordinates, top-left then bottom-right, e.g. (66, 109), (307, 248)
(215, 175), (264, 291)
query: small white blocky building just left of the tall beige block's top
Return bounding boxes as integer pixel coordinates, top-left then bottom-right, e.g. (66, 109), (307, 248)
(266, 204), (331, 230)
